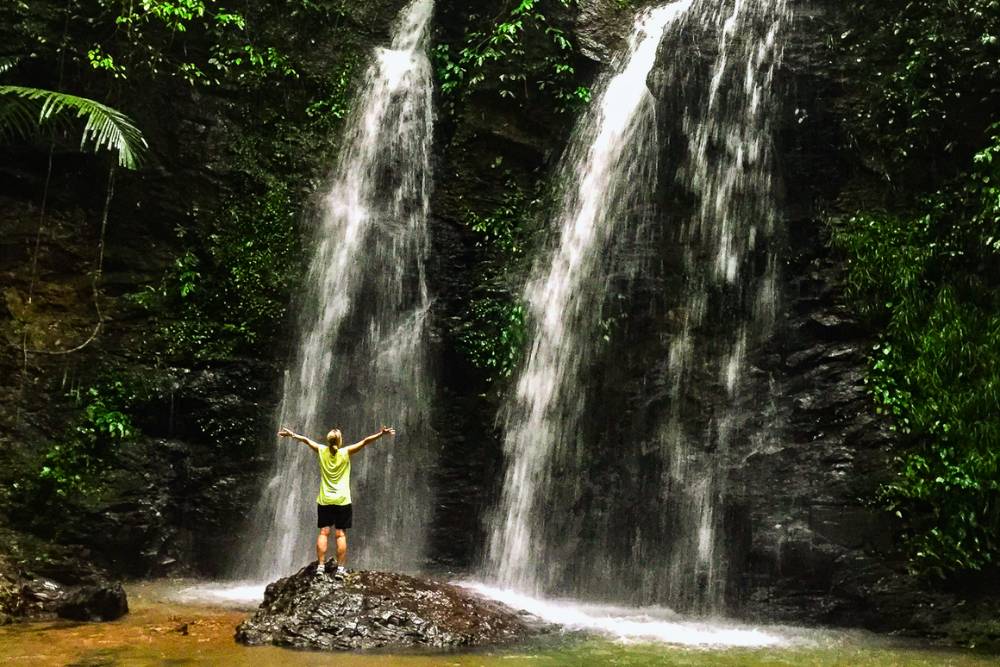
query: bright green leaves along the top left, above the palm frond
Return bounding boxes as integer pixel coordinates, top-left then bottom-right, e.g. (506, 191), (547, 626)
(0, 0), (296, 89)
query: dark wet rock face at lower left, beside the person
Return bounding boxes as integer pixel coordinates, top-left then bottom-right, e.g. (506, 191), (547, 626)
(0, 360), (280, 577)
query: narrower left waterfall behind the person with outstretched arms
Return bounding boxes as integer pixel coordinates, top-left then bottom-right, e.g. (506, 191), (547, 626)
(236, 0), (435, 580)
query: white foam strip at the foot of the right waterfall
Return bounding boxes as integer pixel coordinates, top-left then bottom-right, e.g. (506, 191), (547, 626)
(456, 581), (801, 648)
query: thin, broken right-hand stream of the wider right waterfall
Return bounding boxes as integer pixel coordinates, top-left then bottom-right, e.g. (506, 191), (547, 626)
(661, 0), (788, 611)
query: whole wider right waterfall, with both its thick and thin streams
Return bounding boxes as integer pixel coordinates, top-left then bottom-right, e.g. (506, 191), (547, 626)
(487, 0), (787, 612)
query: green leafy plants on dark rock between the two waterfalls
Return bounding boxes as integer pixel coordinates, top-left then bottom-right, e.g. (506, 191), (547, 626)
(432, 0), (590, 388)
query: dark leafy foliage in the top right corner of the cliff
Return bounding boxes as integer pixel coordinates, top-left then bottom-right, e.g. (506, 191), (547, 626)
(843, 0), (1000, 181)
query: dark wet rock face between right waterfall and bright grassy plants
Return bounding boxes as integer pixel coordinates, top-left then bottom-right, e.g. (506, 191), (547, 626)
(716, 0), (896, 628)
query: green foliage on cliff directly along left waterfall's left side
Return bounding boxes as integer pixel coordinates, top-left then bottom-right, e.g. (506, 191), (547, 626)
(106, 3), (366, 363)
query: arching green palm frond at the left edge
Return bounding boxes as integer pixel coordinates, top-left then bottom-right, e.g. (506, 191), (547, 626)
(0, 86), (149, 169)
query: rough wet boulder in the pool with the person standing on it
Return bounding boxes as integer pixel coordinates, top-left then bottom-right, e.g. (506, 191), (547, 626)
(236, 565), (537, 651)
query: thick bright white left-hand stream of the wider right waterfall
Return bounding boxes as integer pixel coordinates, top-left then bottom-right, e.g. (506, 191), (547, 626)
(488, 0), (691, 592)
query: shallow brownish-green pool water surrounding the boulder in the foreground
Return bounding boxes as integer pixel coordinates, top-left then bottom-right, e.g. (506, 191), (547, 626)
(0, 582), (998, 667)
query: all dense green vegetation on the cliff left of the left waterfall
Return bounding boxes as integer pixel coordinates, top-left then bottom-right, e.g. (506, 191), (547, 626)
(0, 0), (383, 500)
